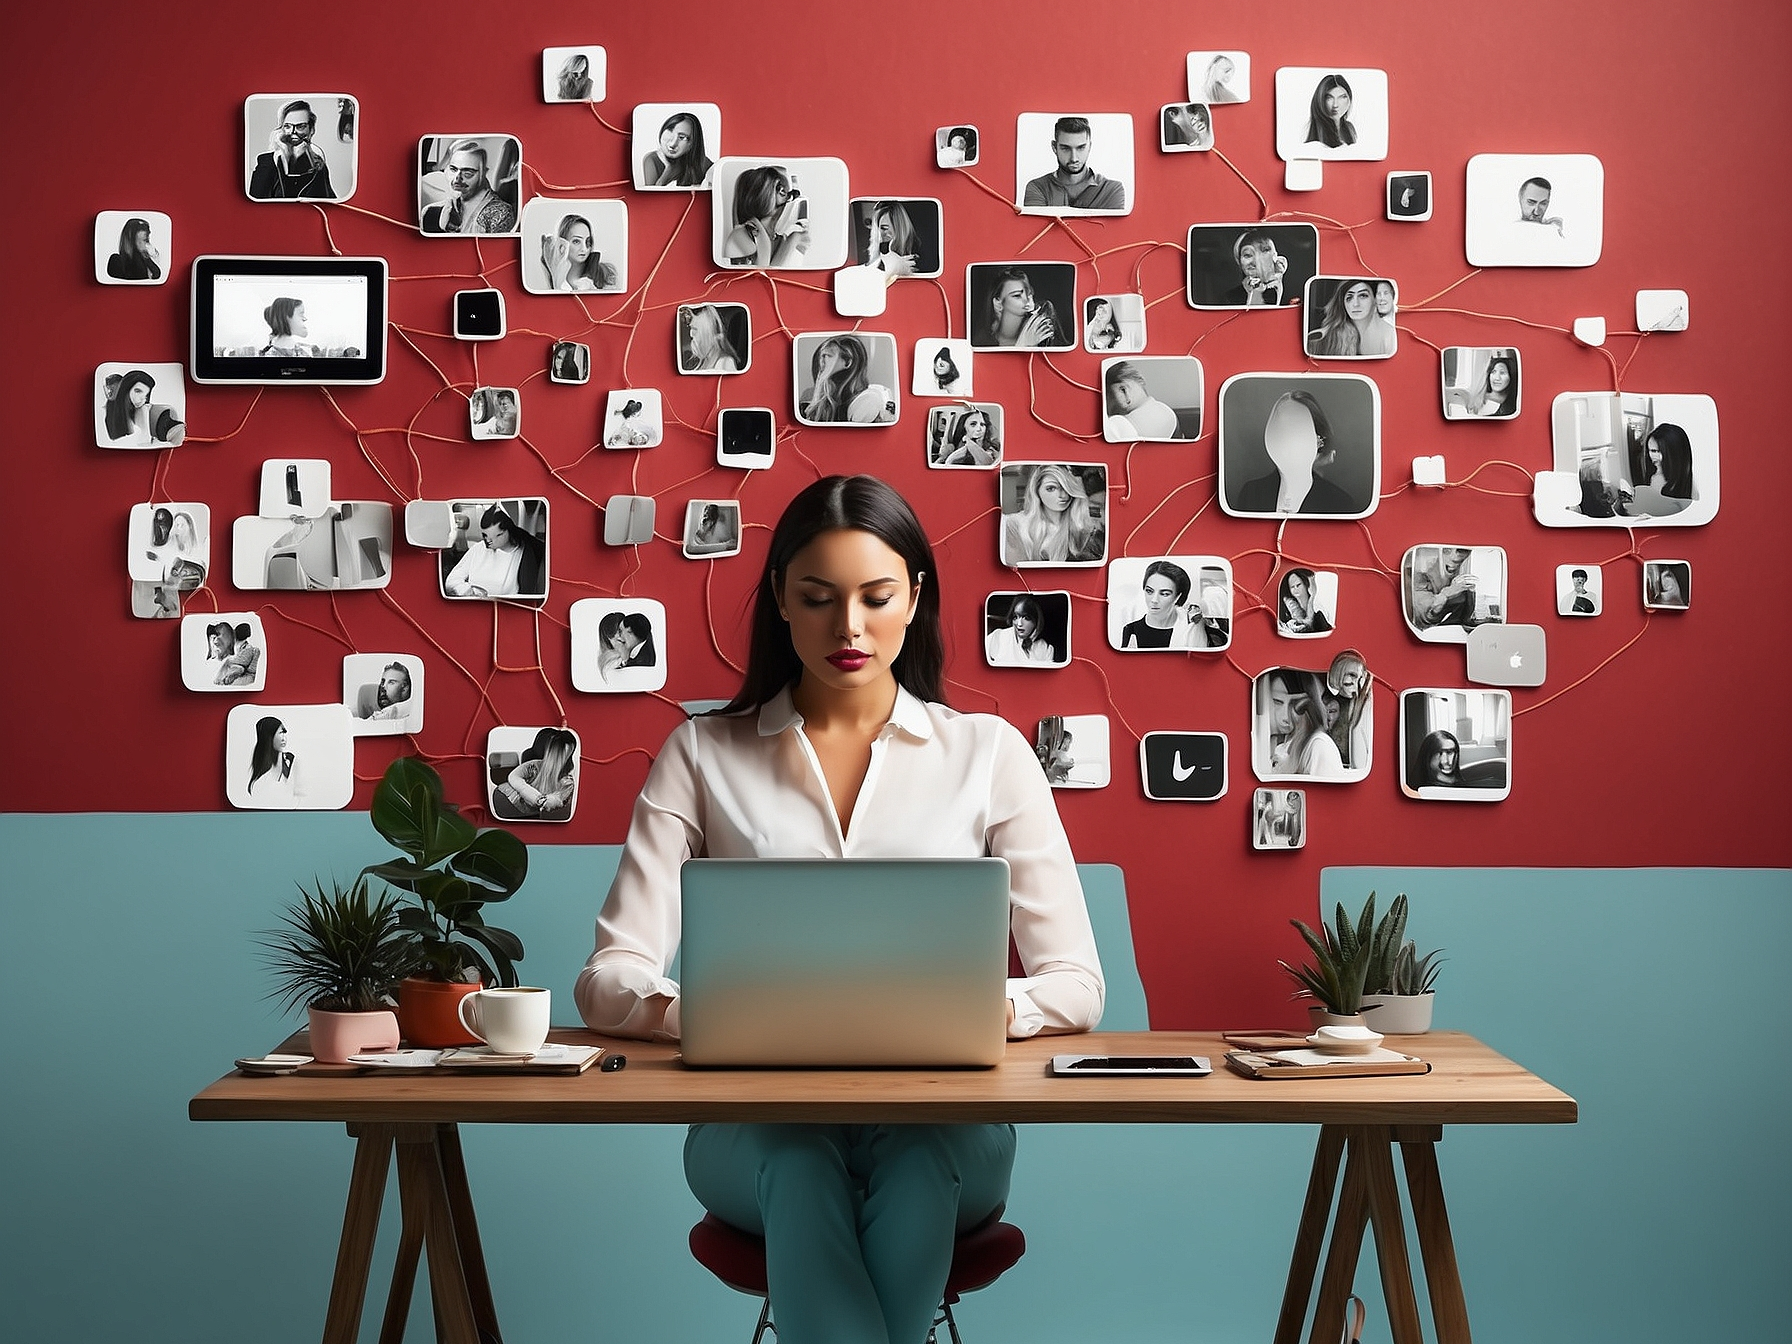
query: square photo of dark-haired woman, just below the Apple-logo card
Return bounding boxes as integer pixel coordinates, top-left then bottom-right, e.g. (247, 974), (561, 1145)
(1400, 686), (1512, 803)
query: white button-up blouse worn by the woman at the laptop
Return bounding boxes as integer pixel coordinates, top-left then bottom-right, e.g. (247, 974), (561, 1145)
(573, 690), (1104, 1039)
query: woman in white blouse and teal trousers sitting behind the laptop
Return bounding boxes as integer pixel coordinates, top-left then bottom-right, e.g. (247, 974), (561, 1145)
(575, 477), (1102, 1344)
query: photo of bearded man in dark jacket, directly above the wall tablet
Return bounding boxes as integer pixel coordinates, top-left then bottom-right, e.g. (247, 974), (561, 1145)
(242, 93), (360, 201)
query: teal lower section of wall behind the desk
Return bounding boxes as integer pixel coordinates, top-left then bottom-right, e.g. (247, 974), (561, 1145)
(0, 814), (1792, 1344)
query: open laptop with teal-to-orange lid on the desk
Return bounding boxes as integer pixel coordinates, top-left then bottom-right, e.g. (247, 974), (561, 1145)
(679, 858), (1009, 1068)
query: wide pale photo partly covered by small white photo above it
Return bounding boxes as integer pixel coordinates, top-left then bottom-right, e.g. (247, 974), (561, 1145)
(231, 500), (392, 593)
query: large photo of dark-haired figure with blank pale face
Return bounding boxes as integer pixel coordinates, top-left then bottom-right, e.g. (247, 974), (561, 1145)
(1219, 373), (1382, 518)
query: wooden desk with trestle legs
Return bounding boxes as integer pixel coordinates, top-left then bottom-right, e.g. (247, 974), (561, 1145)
(186, 1030), (1575, 1344)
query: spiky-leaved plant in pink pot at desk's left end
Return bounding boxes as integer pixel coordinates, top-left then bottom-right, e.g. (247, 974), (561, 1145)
(262, 878), (412, 1064)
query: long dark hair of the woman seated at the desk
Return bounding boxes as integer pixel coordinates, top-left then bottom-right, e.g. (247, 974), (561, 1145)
(715, 477), (946, 713)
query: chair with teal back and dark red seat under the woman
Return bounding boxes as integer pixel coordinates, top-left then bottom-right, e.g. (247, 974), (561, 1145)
(688, 864), (1150, 1344)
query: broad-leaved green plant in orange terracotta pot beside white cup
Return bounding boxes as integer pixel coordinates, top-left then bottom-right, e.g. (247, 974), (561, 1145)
(364, 756), (529, 1047)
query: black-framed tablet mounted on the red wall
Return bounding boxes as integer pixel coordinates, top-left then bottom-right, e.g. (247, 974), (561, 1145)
(192, 256), (387, 383)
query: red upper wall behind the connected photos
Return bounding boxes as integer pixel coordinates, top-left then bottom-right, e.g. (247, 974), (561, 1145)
(17, 0), (1792, 1027)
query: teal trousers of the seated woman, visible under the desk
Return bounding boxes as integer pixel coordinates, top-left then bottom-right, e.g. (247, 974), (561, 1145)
(685, 1125), (1014, 1344)
